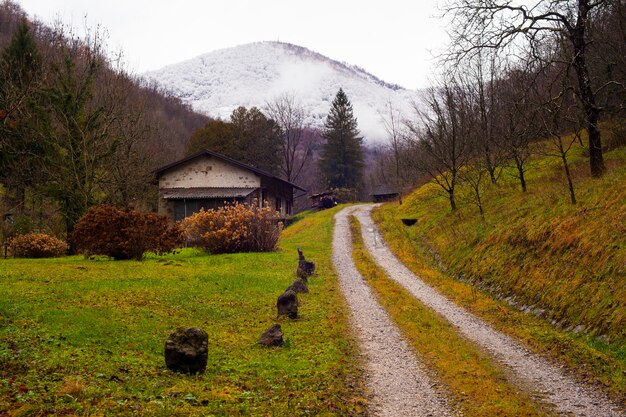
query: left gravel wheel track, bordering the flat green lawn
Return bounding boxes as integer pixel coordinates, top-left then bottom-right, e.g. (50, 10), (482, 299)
(333, 207), (454, 417)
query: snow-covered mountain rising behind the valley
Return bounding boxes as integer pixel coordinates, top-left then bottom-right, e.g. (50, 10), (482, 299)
(144, 42), (417, 142)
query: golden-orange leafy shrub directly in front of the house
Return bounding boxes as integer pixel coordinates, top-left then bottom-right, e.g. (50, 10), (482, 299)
(181, 199), (282, 254)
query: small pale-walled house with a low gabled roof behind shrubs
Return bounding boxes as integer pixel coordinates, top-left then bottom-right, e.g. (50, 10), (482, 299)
(155, 150), (306, 221)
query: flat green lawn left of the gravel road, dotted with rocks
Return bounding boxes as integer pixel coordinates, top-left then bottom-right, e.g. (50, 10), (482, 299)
(0, 206), (365, 416)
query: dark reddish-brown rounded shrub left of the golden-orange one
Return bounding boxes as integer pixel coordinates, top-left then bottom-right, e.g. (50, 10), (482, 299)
(72, 205), (182, 260)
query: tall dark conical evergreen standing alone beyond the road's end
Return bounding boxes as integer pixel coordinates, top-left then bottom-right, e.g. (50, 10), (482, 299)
(319, 88), (363, 189)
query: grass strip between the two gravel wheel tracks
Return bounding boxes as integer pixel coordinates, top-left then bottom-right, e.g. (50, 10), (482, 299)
(350, 217), (548, 417)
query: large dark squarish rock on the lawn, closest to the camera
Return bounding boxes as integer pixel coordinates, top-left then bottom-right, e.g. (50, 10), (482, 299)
(165, 327), (209, 374)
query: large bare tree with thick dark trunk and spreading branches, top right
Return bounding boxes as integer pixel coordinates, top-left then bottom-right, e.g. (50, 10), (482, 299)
(444, 0), (609, 177)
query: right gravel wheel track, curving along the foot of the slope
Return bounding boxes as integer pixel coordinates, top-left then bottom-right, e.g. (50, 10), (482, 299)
(352, 205), (626, 417)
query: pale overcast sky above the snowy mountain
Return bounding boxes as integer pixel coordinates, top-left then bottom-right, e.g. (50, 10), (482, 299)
(17, 0), (446, 88)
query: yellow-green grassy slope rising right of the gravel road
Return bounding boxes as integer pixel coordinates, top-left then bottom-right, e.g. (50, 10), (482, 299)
(375, 144), (626, 399)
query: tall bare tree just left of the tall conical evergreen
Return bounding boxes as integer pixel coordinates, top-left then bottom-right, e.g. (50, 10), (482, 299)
(266, 93), (313, 182)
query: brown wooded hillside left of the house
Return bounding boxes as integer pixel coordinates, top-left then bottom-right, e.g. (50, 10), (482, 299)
(0, 1), (208, 234)
